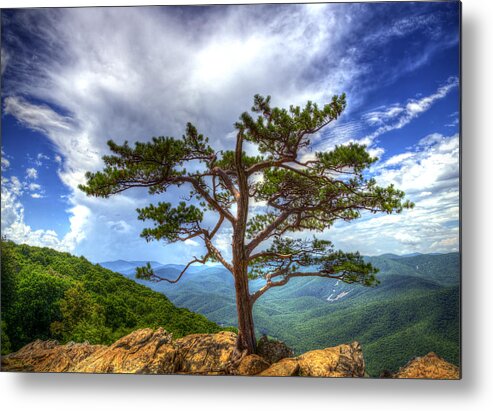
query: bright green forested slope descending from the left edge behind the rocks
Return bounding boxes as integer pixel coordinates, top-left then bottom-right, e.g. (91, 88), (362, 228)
(1, 240), (226, 354)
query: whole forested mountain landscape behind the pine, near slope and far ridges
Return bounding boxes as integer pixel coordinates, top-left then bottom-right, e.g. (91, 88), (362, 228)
(2, 241), (460, 376)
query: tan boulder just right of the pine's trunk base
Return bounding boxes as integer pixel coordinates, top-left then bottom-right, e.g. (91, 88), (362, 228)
(259, 341), (365, 377)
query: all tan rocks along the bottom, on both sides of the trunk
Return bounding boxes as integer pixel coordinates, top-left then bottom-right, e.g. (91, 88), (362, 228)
(2, 328), (459, 379)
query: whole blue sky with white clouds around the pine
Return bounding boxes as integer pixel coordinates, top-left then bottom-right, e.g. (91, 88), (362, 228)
(1, 2), (459, 263)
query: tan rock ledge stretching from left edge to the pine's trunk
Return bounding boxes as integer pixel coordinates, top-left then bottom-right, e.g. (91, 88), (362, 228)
(2, 328), (236, 375)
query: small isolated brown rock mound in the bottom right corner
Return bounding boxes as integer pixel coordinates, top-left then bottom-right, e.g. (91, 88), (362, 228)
(393, 352), (460, 380)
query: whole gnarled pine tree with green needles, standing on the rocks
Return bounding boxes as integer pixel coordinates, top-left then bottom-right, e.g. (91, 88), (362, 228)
(80, 95), (412, 352)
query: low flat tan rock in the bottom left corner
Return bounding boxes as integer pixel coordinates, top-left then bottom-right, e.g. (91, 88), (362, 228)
(2, 340), (105, 372)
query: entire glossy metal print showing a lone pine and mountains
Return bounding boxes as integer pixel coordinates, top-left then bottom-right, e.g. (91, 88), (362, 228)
(1, 1), (461, 379)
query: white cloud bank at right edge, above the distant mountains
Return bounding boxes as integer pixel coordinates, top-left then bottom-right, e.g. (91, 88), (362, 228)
(327, 134), (459, 254)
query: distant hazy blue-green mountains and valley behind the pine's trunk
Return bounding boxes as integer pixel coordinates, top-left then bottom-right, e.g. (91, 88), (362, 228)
(101, 253), (460, 375)
